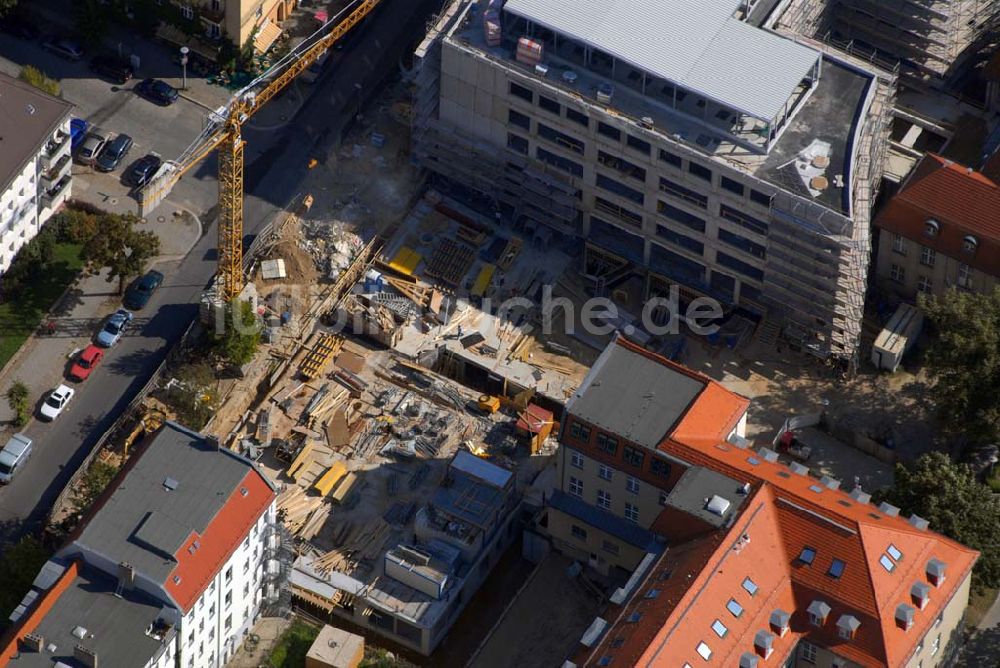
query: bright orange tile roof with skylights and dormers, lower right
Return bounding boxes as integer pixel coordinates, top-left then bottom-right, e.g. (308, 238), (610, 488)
(576, 342), (978, 666)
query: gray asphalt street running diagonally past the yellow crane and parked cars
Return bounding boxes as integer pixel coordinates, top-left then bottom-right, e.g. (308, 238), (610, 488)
(0, 0), (440, 543)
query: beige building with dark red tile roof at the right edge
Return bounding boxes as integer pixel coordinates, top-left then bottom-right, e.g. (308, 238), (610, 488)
(875, 154), (1000, 300)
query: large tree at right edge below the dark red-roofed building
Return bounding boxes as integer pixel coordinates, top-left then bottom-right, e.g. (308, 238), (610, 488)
(920, 287), (1000, 442)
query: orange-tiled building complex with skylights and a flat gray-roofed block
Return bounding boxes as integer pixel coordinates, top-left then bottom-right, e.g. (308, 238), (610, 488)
(539, 338), (978, 668)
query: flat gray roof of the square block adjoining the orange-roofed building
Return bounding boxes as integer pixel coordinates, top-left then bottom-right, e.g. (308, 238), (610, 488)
(566, 343), (705, 448)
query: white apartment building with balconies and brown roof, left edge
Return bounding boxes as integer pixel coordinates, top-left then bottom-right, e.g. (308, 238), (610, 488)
(0, 73), (73, 276)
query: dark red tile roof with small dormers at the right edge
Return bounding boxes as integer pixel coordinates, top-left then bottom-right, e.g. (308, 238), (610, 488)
(875, 153), (1000, 275)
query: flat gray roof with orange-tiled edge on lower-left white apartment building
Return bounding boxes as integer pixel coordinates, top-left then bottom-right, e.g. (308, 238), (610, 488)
(75, 422), (268, 596)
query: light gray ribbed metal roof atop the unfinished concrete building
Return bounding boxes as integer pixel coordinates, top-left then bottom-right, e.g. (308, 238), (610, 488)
(504, 0), (820, 120)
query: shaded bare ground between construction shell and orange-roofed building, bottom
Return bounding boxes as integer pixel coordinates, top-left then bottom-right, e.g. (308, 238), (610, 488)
(469, 552), (598, 668)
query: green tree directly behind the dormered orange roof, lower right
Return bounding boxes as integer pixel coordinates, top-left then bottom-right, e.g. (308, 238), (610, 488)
(875, 452), (1000, 591)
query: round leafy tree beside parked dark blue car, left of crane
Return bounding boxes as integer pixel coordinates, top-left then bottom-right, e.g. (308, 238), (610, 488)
(83, 213), (160, 294)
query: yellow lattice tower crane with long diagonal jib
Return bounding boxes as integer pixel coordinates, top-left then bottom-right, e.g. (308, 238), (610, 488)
(139, 0), (381, 302)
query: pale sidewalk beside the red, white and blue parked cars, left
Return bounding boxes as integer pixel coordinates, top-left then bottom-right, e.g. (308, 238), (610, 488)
(0, 201), (201, 429)
